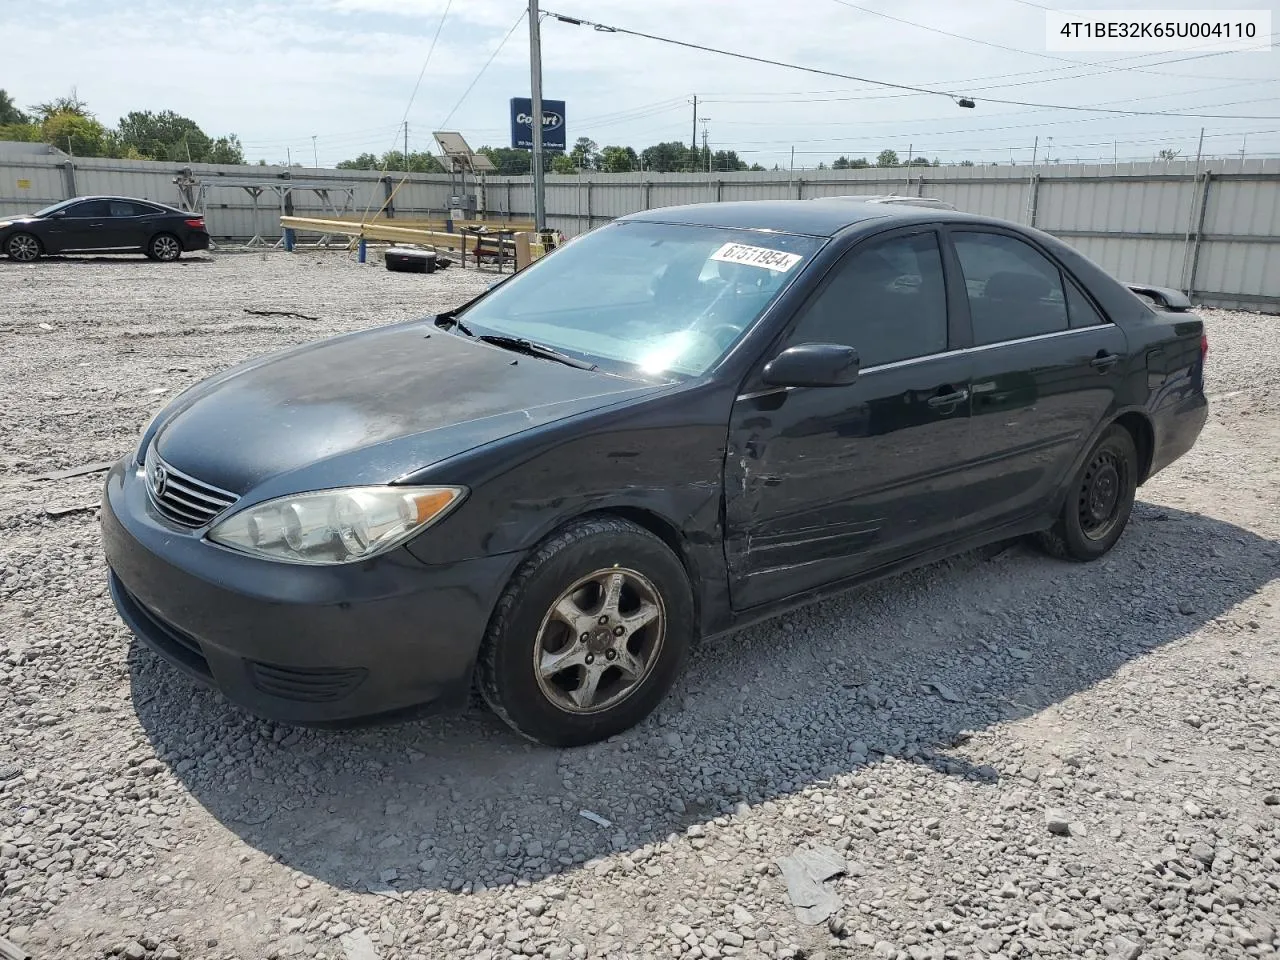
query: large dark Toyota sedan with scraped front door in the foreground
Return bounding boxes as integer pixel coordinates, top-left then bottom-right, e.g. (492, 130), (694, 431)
(102, 201), (1207, 745)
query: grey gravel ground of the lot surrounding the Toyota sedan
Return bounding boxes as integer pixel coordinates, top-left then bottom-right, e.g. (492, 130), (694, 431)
(0, 253), (1280, 960)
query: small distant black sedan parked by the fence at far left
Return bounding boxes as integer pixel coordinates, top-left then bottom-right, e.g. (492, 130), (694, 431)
(0, 197), (209, 264)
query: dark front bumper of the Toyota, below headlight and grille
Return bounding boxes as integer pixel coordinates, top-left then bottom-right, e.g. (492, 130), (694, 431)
(102, 456), (520, 723)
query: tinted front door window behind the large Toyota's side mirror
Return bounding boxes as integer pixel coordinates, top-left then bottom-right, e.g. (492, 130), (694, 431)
(788, 230), (947, 367)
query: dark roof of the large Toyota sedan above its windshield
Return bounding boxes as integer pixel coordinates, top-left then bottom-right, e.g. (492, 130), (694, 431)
(618, 197), (1012, 237)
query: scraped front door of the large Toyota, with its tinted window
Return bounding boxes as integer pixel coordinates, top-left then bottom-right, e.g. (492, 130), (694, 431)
(724, 227), (970, 609)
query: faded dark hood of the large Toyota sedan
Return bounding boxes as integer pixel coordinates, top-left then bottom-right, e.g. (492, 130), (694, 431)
(154, 320), (667, 499)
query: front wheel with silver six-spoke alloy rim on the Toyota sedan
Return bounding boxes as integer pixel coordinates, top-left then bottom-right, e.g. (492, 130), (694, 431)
(476, 516), (694, 746)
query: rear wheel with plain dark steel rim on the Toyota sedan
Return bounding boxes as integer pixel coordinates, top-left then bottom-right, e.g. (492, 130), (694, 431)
(1039, 425), (1138, 562)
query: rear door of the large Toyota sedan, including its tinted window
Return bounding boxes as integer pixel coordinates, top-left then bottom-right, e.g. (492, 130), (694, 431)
(947, 227), (1129, 526)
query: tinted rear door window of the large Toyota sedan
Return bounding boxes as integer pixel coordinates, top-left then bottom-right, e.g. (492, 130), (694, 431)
(951, 232), (1069, 346)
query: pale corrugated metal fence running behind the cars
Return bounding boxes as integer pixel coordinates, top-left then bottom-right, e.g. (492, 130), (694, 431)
(0, 145), (1280, 312)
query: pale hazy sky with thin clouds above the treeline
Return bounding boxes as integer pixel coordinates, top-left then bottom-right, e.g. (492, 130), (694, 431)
(0, 0), (1280, 166)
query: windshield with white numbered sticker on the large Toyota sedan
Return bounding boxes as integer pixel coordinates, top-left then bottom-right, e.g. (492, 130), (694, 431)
(458, 221), (822, 379)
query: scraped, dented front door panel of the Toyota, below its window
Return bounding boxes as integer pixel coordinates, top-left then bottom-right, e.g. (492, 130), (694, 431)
(726, 364), (968, 607)
